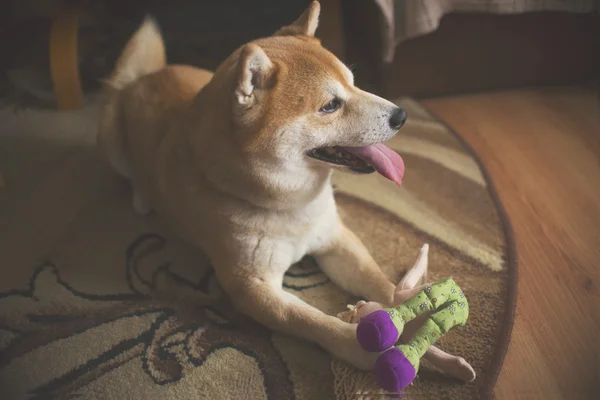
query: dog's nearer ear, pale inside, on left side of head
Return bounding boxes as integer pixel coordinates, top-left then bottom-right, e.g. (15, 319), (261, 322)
(235, 43), (275, 106)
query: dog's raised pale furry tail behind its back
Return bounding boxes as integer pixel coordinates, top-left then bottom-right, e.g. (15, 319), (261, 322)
(106, 16), (167, 90)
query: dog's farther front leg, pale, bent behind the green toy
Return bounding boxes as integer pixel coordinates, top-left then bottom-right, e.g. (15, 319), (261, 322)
(312, 224), (395, 306)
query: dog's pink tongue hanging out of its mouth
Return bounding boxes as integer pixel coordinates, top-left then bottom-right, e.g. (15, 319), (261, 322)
(343, 143), (404, 185)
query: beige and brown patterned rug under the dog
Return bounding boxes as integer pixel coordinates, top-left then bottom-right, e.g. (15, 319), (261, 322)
(0, 99), (516, 400)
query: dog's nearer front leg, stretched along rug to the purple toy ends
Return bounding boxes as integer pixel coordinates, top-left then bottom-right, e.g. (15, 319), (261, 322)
(215, 265), (378, 370)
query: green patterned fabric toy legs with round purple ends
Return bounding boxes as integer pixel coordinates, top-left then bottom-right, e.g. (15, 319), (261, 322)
(356, 278), (469, 392)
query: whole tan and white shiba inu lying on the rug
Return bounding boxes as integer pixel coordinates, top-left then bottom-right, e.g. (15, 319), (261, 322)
(98, 2), (474, 376)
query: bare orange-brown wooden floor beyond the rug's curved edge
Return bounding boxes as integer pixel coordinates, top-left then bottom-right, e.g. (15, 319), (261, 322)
(424, 88), (600, 400)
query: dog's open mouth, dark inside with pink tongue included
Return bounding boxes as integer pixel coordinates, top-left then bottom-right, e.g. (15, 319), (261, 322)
(307, 143), (404, 185)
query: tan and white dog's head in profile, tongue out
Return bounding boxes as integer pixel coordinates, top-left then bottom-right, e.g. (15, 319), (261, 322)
(227, 1), (406, 184)
